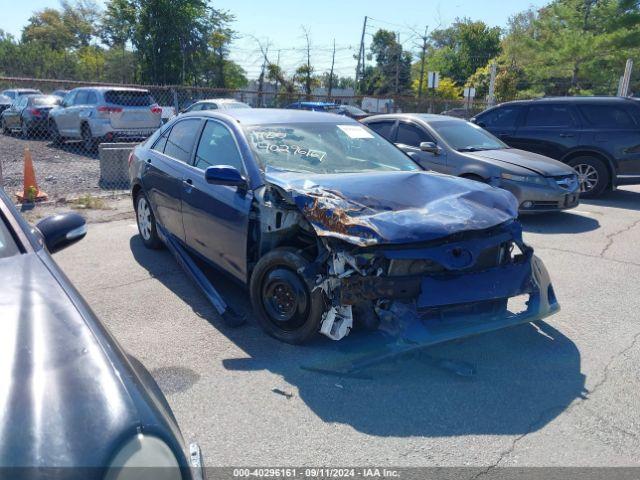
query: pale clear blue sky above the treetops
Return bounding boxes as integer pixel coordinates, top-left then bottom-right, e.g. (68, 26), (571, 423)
(0, 0), (548, 78)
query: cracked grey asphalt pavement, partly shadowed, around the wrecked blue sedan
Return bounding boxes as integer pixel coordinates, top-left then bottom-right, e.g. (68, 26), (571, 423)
(56, 187), (640, 469)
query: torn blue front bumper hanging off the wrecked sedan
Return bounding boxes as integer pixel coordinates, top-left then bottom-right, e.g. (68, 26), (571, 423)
(303, 254), (560, 375)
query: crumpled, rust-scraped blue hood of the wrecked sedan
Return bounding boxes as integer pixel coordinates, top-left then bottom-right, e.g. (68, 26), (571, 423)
(266, 169), (518, 246)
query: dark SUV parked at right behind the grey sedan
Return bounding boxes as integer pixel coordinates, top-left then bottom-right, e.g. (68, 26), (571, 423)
(471, 97), (640, 197)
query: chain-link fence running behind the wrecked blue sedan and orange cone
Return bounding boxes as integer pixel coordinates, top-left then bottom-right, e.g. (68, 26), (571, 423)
(0, 77), (486, 201)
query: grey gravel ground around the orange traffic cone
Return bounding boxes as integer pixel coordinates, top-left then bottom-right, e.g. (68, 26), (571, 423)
(0, 129), (124, 200)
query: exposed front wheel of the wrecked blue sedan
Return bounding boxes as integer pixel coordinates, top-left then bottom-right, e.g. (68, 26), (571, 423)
(249, 248), (325, 344)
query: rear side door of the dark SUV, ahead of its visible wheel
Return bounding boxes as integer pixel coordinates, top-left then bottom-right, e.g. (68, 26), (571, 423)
(509, 102), (580, 160)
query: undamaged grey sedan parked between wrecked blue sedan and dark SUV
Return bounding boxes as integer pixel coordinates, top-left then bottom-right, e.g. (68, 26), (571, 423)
(362, 113), (580, 213)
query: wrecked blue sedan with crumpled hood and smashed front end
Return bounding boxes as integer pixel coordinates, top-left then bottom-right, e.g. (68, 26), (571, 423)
(129, 109), (559, 350)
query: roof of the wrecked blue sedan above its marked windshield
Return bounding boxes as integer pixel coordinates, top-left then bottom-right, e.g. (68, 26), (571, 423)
(182, 108), (359, 125)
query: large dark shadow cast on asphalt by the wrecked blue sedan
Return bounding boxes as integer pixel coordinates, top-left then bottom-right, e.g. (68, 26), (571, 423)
(130, 235), (585, 437)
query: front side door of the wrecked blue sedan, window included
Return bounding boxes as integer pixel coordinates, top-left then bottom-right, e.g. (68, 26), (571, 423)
(182, 120), (253, 282)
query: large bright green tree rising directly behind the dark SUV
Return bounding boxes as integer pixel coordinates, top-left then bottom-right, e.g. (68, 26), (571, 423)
(500, 0), (640, 95)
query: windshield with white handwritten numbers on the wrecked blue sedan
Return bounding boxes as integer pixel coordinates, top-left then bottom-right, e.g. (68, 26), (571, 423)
(245, 123), (420, 173)
